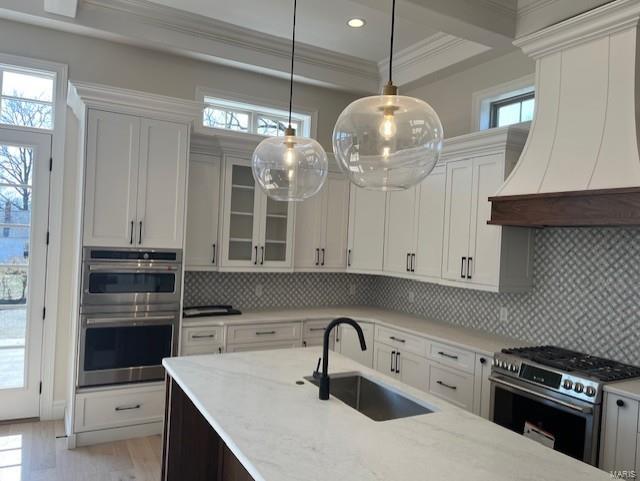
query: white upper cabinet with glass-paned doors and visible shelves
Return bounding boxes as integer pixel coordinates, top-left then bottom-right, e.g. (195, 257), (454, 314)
(220, 156), (295, 271)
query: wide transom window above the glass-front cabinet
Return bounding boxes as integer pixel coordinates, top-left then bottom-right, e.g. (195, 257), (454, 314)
(202, 97), (311, 137)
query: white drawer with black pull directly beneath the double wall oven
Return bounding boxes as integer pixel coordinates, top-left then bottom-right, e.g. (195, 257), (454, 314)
(75, 384), (165, 432)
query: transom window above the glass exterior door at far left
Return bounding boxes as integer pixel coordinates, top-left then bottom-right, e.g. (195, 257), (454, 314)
(0, 65), (55, 130)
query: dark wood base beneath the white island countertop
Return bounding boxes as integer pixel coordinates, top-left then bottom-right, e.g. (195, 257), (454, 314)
(161, 377), (254, 481)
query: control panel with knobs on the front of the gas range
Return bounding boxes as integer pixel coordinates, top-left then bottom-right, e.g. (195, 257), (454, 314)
(493, 353), (601, 403)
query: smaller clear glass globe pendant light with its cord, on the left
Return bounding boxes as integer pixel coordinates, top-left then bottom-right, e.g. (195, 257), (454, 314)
(252, 0), (329, 202)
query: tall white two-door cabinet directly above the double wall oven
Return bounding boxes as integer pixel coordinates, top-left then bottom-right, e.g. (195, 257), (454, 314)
(84, 110), (189, 248)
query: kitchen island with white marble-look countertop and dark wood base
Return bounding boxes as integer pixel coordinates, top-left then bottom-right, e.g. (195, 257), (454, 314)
(163, 348), (611, 481)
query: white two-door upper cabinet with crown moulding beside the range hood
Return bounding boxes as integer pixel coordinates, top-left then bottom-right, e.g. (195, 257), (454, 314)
(442, 129), (533, 291)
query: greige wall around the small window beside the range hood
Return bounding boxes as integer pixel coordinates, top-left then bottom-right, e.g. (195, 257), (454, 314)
(401, 50), (535, 138)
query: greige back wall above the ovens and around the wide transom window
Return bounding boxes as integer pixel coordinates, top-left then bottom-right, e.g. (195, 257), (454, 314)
(0, 20), (354, 401)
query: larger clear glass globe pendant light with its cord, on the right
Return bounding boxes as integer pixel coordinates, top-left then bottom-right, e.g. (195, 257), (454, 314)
(333, 0), (444, 190)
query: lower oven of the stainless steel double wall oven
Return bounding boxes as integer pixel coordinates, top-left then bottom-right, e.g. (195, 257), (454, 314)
(77, 309), (179, 387)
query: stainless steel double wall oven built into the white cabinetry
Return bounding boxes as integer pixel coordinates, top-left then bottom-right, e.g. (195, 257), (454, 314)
(77, 247), (182, 387)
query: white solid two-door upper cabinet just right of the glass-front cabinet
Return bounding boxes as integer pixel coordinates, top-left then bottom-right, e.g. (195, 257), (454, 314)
(294, 173), (349, 271)
